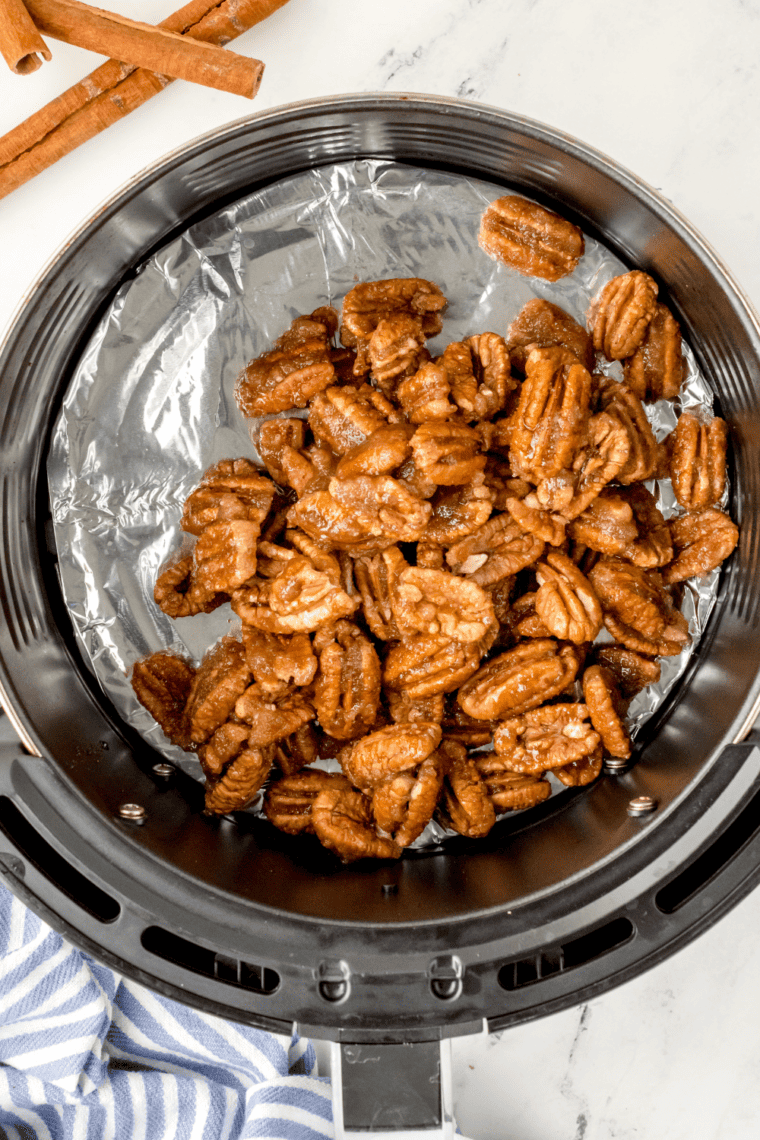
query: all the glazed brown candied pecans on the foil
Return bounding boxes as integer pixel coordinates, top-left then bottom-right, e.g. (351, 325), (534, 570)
(132, 196), (738, 861)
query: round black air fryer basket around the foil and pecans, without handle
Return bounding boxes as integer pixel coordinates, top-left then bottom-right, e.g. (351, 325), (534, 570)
(0, 95), (760, 1042)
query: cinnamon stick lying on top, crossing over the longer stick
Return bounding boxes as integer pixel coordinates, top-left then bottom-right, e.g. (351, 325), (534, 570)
(24, 0), (264, 99)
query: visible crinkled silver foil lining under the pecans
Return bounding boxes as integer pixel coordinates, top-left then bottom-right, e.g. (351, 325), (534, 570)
(48, 160), (718, 842)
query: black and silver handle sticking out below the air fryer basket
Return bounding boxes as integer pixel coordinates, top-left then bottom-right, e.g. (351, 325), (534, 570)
(330, 1039), (471, 1140)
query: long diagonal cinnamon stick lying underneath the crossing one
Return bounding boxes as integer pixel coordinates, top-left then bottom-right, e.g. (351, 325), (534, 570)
(0, 0), (287, 198)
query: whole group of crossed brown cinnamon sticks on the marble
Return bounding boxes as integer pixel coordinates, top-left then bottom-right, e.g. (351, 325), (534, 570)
(0, 0), (287, 197)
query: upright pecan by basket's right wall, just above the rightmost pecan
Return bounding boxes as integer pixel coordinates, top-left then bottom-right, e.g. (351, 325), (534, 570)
(667, 412), (728, 511)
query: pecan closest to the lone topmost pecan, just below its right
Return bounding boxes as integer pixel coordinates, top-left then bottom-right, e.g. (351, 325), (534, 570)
(588, 269), (657, 360)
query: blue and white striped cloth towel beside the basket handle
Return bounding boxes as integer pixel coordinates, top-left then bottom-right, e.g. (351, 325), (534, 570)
(0, 884), (334, 1140)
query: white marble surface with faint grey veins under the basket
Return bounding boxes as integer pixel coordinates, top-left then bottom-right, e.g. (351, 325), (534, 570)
(0, 0), (760, 1140)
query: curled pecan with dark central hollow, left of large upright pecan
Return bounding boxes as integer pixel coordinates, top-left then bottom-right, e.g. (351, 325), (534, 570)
(438, 333), (516, 422)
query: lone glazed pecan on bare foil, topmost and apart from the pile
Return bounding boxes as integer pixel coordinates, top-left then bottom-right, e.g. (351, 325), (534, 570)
(477, 194), (583, 282)
